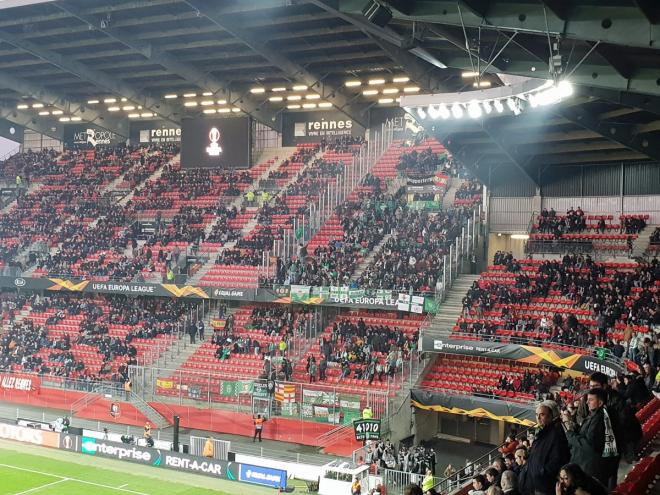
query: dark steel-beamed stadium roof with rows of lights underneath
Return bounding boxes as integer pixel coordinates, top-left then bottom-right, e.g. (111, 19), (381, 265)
(0, 0), (660, 178)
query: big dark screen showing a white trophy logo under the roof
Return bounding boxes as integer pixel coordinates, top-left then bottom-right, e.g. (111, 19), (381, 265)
(181, 117), (250, 168)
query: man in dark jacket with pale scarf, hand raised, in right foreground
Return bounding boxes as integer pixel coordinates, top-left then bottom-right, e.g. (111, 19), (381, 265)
(562, 388), (619, 486)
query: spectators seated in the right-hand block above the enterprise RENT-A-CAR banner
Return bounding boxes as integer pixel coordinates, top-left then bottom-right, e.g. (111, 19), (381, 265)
(459, 252), (660, 348)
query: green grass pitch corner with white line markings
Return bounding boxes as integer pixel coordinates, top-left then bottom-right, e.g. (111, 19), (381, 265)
(0, 449), (236, 495)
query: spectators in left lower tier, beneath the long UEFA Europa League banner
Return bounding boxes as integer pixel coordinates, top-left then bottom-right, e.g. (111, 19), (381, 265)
(0, 293), (196, 381)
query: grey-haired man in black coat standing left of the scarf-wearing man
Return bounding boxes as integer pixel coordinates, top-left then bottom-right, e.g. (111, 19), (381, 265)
(519, 400), (570, 495)
